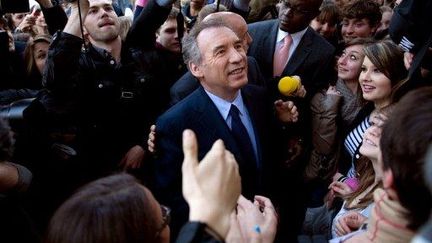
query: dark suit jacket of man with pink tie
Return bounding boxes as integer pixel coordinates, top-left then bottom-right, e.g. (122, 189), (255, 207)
(248, 19), (336, 97)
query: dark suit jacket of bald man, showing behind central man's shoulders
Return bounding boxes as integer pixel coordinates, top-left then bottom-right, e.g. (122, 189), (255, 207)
(170, 56), (265, 105)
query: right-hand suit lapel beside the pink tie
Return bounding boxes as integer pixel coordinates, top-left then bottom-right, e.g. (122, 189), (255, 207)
(282, 27), (313, 76)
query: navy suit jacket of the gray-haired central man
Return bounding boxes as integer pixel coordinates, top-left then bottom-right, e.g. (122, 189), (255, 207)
(152, 85), (282, 236)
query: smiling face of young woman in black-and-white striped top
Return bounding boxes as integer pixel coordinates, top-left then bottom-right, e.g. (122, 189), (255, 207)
(359, 56), (392, 108)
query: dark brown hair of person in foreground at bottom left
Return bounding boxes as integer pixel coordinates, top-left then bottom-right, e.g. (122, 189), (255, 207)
(45, 173), (160, 243)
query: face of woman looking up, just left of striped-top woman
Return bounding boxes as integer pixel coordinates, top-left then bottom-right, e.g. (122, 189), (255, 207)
(337, 45), (364, 82)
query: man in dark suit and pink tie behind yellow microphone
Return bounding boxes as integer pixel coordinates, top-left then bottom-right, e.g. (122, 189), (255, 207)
(248, 0), (335, 96)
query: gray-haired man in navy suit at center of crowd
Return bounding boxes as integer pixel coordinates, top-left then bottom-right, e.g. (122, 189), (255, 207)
(152, 21), (298, 239)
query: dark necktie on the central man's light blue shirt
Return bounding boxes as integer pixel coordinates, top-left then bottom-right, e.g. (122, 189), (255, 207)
(229, 105), (257, 166)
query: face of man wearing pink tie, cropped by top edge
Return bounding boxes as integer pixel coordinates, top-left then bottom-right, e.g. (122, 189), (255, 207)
(277, 0), (319, 33)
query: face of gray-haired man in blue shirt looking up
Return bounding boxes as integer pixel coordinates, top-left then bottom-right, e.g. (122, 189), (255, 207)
(189, 27), (248, 100)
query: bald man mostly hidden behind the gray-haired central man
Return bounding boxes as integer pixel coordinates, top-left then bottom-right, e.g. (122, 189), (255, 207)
(170, 12), (265, 105)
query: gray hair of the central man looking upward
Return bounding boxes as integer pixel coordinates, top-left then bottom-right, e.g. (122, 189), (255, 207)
(182, 19), (232, 66)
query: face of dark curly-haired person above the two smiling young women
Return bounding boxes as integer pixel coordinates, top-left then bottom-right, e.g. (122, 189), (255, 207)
(341, 18), (376, 42)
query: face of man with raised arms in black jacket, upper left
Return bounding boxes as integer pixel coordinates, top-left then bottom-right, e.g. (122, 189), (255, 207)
(84, 0), (120, 42)
